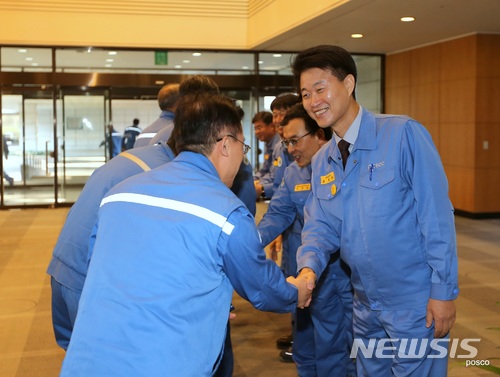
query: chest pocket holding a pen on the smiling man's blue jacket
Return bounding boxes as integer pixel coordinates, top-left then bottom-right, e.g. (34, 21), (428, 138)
(359, 170), (401, 217)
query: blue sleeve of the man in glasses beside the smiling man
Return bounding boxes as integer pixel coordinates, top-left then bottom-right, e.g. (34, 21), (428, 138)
(257, 175), (297, 246)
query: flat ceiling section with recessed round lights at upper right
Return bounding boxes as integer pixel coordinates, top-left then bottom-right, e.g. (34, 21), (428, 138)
(256, 0), (500, 54)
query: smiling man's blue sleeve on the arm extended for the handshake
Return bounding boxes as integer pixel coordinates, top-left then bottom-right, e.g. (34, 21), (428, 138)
(297, 179), (342, 277)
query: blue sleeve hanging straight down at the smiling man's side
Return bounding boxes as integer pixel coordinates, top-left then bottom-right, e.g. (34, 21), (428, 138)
(401, 121), (458, 300)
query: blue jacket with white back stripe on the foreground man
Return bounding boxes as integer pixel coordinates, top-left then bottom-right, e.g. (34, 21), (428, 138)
(61, 152), (297, 377)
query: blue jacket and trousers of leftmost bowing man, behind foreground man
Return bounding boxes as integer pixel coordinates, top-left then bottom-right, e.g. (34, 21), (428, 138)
(47, 143), (174, 349)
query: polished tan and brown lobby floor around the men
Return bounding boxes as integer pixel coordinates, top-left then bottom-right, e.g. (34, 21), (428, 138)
(0, 207), (500, 377)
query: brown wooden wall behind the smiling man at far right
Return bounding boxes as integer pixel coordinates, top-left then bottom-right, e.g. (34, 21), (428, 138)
(385, 35), (500, 214)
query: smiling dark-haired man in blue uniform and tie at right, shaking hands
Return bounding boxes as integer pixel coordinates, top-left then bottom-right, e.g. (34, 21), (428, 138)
(292, 46), (458, 377)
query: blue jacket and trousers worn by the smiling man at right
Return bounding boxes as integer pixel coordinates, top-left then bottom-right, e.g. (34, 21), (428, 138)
(298, 109), (458, 376)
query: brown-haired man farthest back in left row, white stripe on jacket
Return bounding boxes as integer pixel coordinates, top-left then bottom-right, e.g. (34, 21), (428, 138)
(134, 84), (179, 148)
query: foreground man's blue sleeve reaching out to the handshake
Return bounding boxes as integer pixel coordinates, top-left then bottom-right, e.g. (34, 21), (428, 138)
(219, 210), (298, 313)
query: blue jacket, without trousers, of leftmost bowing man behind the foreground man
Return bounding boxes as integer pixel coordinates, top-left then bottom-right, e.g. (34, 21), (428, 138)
(47, 143), (174, 292)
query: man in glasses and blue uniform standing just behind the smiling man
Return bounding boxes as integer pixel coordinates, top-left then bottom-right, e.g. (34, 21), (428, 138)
(257, 104), (355, 377)
